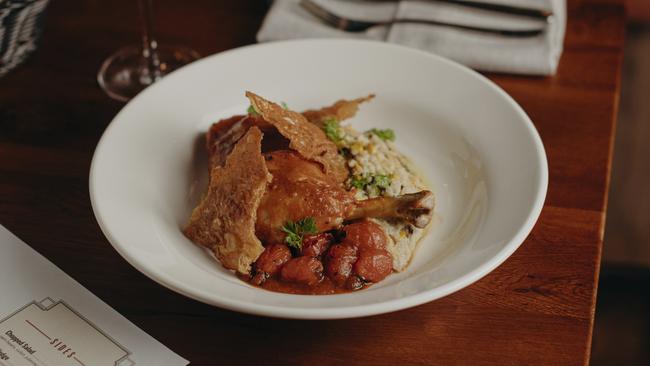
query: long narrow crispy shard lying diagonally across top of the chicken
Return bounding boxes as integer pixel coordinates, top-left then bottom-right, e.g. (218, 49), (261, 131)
(246, 92), (349, 183)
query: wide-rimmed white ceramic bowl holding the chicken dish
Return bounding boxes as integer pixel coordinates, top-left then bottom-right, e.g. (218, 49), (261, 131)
(90, 40), (548, 319)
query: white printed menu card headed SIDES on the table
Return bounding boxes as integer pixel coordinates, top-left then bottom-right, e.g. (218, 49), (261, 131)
(0, 225), (188, 366)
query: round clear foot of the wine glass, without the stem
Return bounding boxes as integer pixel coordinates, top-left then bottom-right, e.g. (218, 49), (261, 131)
(97, 46), (200, 102)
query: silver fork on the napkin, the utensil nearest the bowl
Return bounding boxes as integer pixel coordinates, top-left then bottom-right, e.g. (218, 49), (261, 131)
(300, 0), (551, 38)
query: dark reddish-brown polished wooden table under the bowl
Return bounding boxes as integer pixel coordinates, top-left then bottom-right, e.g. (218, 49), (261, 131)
(0, 0), (624, 365)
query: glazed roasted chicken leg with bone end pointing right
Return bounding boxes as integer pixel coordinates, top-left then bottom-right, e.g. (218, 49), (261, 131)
(255, 150), (434, 243)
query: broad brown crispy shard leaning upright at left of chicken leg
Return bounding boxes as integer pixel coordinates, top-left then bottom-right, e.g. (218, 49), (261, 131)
(183, 127), (272, 274)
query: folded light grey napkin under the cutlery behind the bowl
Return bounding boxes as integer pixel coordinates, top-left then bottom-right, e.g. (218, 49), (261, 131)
(257, 0), (566, 75)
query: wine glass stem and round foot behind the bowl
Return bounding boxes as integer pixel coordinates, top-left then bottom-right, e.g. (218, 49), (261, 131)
(97, 0), (200, 102)
